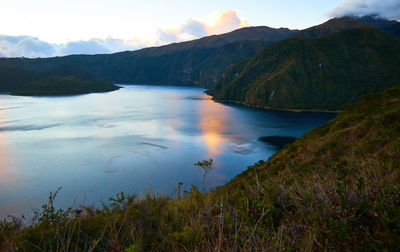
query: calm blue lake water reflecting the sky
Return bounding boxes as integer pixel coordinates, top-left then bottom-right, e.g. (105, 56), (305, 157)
(0, 85), (334, 217)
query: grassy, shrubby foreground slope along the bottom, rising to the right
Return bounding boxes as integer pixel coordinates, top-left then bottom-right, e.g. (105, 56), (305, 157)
(0, 87), (400, 251)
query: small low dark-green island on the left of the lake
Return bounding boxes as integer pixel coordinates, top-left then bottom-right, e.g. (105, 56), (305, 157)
(10, 76), (120, 96)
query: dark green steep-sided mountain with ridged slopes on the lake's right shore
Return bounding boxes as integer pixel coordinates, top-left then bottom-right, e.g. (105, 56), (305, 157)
(210, 27), (400, 111)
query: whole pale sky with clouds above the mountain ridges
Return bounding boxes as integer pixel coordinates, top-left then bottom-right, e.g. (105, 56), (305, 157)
(0, 0), (400, 58)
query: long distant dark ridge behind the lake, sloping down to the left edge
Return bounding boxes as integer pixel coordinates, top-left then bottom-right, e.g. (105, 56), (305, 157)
(0, 26), (296, 89)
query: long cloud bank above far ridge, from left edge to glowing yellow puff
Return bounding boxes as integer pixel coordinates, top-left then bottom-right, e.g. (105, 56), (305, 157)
(0, 10), (248, 58)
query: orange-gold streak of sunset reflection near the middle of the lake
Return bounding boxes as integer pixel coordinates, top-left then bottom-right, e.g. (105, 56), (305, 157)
(198, 95), (227, 155)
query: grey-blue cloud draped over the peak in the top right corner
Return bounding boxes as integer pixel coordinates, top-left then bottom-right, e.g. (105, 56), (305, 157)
(329, 0), (400, 20)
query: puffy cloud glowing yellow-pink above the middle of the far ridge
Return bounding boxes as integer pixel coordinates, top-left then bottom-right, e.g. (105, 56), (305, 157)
(157, 10), (249, 44)
